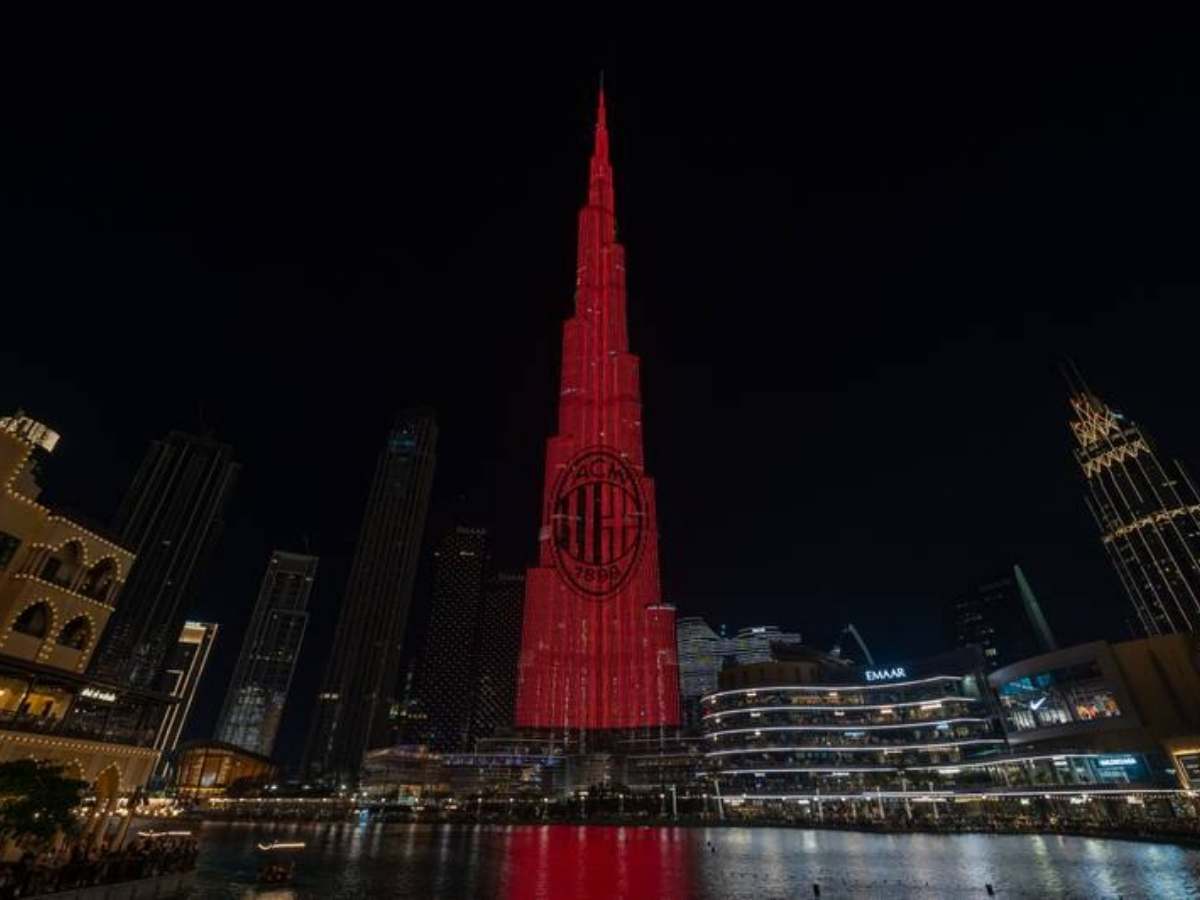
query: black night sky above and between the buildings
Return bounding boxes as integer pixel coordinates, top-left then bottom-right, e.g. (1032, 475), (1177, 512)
(0, 23), (1200, 757)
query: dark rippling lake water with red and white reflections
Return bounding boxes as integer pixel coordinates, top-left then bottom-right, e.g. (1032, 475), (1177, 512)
(193, 823), (1200, 900)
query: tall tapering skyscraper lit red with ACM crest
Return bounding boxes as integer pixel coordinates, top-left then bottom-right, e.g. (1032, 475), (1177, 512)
(516, 90), (679, 731)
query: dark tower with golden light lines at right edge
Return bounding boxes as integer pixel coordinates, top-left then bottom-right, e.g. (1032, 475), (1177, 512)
(1068, 372), (1200, 635)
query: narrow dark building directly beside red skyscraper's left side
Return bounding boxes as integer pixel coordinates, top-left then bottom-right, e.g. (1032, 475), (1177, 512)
(472, 572), (524, 738)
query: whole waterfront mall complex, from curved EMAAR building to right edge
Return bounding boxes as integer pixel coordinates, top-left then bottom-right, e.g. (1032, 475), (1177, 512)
(702, 637), (1200, 817)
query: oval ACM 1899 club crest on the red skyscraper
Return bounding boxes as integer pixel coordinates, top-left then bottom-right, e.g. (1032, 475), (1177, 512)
(551, 448), (646, 596)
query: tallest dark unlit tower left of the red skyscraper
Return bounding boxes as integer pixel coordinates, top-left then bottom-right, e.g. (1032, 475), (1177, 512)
(305, 410), (438, 781)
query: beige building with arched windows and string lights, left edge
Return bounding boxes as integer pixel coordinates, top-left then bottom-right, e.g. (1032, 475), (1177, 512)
(0, 413), (173, 810)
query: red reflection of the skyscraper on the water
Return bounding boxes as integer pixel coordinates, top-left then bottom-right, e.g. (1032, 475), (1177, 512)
(497, 826), (694, 900)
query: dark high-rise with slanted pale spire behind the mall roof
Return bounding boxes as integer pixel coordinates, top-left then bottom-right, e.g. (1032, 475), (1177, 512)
(947, 565), (1057, 671)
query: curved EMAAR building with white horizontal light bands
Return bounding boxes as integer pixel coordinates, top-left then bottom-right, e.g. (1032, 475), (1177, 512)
(702, 648), (1007, 799)
